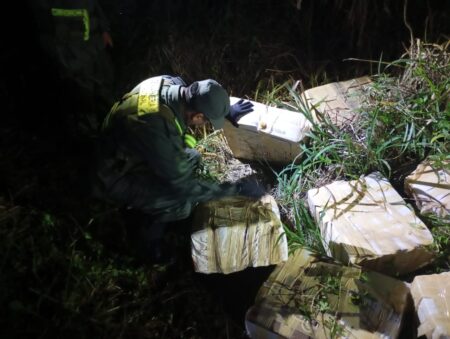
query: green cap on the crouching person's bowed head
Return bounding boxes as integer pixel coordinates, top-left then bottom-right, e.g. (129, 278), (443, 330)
(192, 79), (230, 129)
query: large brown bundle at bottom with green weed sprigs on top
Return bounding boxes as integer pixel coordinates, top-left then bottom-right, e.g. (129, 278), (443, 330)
(245, 249), (409, 339)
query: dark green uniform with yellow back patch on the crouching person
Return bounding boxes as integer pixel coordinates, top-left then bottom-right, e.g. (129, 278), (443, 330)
(96, 76), (236, 222)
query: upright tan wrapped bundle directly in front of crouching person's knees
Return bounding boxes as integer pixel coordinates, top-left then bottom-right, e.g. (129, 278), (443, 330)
(191, 195), (288, 273)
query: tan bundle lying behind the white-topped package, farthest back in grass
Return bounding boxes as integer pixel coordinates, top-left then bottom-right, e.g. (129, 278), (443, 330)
(303, 76), (371, 126)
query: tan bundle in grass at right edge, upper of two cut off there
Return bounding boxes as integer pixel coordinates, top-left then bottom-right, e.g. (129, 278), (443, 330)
(405, 161), (450, 220)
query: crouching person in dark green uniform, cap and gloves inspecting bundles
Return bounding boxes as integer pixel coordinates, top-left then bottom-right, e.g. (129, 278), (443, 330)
(94, 76), (264, 263)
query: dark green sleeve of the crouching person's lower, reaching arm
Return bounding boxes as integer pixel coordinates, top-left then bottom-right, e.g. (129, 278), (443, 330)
(121, 115), (236, 202)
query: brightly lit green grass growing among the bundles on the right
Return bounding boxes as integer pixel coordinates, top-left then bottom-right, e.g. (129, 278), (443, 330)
(266, 41), (450, 255)
